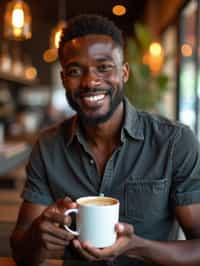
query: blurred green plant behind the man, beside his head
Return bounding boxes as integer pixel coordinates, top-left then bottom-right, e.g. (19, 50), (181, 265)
(125, 24), (169, 110)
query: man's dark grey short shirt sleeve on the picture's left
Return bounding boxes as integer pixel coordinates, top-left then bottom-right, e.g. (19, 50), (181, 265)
(21, 141), (54, 205)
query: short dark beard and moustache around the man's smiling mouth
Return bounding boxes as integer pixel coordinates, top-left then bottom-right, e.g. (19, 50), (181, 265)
(66, 85), (124, 125)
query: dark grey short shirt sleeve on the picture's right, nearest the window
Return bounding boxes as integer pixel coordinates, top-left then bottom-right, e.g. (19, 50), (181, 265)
(171, 126), (200, 206)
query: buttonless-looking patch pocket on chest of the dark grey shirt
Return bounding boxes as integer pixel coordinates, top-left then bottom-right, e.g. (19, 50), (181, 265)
(125, 178), (169, 222)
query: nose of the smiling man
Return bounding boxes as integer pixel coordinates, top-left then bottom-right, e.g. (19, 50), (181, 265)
(81, 69), (101, 88)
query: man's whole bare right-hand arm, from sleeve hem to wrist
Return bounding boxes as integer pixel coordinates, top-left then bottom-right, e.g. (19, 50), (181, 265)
(133, 204), (200, 266)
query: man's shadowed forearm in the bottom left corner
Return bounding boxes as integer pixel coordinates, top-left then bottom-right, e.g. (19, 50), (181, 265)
(11, 230), (64, 266)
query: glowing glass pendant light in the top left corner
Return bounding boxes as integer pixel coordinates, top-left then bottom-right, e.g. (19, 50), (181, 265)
(4, 0), (32, 40)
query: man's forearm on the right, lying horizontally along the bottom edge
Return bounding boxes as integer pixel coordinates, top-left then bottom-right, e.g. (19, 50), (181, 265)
(128, 237), (200, 266)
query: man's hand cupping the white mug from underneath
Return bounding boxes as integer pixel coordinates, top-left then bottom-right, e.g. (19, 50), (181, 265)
(73, 223), (136, 261)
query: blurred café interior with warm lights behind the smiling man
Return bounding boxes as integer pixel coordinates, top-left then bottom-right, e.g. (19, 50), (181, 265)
(0, 0), (200, 265)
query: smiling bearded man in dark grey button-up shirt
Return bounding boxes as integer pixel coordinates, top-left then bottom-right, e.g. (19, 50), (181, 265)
(11, 15), (200, 266)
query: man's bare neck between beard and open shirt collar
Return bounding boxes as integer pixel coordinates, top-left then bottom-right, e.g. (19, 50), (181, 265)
(79, 101), (124, 146)
